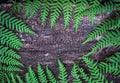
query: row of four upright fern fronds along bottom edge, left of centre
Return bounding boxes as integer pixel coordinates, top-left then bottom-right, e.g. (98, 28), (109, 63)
(25, 60), (68, 83)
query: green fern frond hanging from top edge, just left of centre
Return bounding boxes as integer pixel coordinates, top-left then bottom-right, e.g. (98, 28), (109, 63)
(50, 0), (62, 28)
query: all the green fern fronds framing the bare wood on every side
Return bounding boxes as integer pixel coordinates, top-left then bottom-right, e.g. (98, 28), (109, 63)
(0, 0), (120, 83)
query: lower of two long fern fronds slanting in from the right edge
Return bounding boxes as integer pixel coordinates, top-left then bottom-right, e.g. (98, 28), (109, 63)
(92, 30), (120, 51)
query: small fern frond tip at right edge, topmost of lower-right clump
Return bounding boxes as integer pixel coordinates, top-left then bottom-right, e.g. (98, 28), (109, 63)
(106, 52), (120, 65)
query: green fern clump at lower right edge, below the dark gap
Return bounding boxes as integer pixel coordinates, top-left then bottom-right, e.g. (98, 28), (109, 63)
(98, 52), (120, 77)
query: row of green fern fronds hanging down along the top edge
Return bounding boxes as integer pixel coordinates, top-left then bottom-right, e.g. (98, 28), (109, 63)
(9, 0), (120, 31)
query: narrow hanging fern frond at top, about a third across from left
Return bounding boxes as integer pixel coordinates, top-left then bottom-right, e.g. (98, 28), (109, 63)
(40, 0), (50, 24)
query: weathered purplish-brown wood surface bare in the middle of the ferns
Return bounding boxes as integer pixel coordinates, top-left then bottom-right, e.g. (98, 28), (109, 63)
(0, 6), (119, 83)
